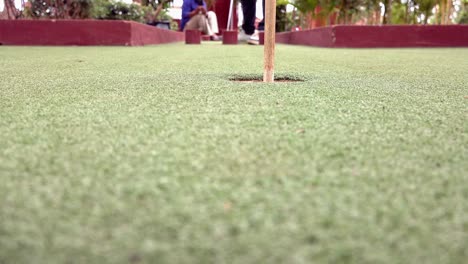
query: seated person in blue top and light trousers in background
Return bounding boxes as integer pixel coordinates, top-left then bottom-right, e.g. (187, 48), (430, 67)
(180, 0), (219, 40)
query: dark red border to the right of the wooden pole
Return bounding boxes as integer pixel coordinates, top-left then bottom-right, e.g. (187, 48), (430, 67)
(276, 25), (468, 48)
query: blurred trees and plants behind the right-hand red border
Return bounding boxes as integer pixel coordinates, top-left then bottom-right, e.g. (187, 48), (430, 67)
(289, 0), (468, 28)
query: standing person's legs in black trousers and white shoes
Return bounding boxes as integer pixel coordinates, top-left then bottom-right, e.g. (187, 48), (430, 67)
(237, 0), (265, 45)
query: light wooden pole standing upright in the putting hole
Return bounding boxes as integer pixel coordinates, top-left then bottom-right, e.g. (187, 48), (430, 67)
(263, 0), (276, 83)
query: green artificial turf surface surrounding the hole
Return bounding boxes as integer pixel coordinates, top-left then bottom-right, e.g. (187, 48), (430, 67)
(0, 44), (468, 264)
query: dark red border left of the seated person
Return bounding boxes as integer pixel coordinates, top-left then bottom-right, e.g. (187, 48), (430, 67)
(0, 20), (184, 46)
